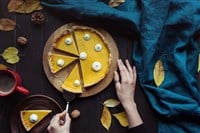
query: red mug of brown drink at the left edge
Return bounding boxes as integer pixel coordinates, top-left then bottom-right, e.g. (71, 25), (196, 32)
(0, 69), (29, 96)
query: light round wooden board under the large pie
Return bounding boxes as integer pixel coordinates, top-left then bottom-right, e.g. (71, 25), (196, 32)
(43, 23), (119, 97)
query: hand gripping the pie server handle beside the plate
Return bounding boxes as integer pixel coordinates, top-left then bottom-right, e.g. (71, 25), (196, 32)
(47, 110), (71, 133)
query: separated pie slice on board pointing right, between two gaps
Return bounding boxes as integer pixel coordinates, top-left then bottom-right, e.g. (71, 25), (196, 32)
(48, 53), (78, 73)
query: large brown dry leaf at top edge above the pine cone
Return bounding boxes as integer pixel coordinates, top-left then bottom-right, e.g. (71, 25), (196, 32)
(8, 0), (42, 13)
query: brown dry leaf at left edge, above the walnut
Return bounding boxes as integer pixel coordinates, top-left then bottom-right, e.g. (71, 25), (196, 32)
(0, 18), (16, 31)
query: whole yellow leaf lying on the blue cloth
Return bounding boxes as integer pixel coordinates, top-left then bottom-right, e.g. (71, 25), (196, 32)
(153, 60), (165, 87)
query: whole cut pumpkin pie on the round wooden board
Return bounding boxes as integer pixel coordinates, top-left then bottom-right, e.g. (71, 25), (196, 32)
(49, 26), (112, 93)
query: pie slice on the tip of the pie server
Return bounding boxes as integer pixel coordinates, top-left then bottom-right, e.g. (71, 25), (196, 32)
(61, 64), (83, 93)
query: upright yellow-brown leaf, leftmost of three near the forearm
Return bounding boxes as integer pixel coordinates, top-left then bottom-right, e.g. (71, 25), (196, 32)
(101, 106), (112, 131)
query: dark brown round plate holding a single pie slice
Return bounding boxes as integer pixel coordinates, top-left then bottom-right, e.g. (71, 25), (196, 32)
(10, 95), (62, 133)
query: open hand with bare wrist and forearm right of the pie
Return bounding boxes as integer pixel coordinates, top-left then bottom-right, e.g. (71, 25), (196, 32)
(114, 60), (143, 128)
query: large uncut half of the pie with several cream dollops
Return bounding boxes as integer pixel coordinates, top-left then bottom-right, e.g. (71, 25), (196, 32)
(74, 28), (111, 87)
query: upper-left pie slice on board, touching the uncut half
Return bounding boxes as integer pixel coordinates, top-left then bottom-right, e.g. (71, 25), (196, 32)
(53, 32), (79, 56)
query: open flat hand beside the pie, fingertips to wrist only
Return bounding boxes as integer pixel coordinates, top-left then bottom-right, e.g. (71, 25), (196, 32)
(114, 59), (137, 108)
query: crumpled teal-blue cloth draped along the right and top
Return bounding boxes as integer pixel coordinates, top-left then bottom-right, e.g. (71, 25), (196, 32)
(42, 0), (200, 133)
